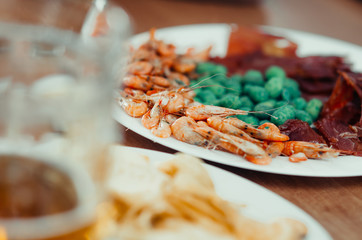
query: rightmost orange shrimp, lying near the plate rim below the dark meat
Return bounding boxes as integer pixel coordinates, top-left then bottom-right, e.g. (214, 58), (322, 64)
(283, 141), (339, 159)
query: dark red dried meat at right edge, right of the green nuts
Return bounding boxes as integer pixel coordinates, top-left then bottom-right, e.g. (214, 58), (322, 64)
(315, 72), (362, 156)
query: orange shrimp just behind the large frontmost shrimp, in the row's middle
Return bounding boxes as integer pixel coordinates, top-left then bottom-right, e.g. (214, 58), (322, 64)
(207, 116), (262, 145)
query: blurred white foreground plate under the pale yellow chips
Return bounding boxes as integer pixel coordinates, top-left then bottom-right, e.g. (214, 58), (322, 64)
(111, 146), (332, 240)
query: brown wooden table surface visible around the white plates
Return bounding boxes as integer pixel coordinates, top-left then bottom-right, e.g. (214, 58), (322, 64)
(115, 0), (362, 239)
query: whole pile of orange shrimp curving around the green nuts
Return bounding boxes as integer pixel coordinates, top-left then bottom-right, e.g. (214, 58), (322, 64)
(119, 29), (339, 165)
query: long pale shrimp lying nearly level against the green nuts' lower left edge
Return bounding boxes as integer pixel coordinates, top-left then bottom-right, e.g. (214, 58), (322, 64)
(185, 104), (248, 120)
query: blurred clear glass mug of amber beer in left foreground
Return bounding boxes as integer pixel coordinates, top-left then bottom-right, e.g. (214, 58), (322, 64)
(0, 0), (130, 239)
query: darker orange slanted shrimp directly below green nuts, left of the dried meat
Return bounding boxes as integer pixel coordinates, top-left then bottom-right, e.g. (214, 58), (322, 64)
(225, 118), (289, 142)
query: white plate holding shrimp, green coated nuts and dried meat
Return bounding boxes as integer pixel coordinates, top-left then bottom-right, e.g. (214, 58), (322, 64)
(114, 24), (362, 177)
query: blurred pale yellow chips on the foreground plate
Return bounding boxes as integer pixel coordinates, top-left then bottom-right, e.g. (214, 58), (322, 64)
(109, 149), (307, 239)
